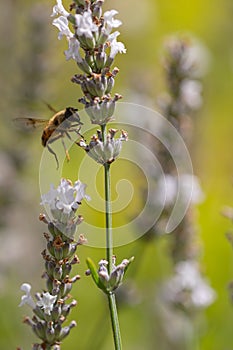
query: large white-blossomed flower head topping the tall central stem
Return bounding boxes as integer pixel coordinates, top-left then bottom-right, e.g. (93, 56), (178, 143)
(51, 0), (126, 129)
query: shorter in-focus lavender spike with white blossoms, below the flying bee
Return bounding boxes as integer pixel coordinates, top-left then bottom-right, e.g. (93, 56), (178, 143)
(20, 179), (87, 350)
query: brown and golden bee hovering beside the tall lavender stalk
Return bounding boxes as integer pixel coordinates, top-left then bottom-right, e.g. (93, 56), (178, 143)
(14, 105), (83, 169)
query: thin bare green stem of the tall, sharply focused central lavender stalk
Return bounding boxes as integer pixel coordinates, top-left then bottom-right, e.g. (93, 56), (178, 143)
(101, 125), (122, 350)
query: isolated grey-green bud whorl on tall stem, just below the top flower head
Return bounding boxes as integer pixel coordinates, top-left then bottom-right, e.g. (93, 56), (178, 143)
(77, 129), (128, 164)
